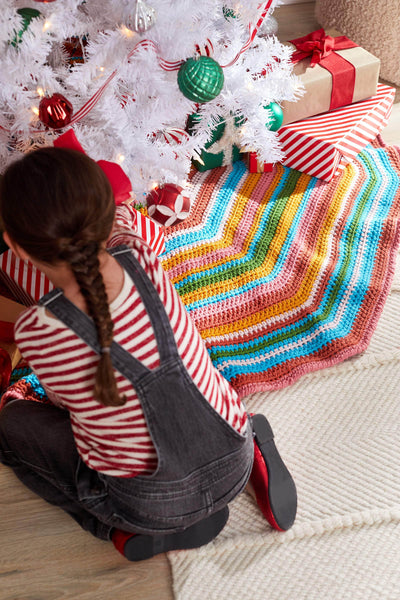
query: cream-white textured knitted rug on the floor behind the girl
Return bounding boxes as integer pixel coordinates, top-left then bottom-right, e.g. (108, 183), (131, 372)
(168, 247), (400, 600)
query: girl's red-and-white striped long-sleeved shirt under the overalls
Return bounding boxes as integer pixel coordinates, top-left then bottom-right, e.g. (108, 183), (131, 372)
(15, 213), (247, 477)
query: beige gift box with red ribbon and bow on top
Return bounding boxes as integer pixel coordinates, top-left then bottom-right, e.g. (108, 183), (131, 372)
(282, 29), (380, 125)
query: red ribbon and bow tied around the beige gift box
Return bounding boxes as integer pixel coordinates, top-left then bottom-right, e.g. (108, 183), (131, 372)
(289, 29), (357, 110)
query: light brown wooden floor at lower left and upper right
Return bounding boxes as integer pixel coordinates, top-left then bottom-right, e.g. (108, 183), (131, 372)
(0, 2), (400, 600)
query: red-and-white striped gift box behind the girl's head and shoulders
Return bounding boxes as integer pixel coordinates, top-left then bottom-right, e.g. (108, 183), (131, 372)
(0, 205), (165, 306)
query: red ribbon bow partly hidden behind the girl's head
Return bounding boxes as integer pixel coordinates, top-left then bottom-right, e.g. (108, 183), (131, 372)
(53, 129), (132, 206)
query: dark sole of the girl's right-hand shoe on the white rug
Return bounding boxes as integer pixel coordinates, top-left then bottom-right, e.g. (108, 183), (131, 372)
(252, 414), (297, 531)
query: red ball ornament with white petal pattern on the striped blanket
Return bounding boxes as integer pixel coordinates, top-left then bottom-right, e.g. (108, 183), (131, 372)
(147, 183), (190, 227)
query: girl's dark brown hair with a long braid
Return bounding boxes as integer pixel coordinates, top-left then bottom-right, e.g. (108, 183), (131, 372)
(0, 147), (125, 406)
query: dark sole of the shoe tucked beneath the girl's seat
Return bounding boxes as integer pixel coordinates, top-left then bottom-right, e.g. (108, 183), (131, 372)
(124, 506), (229, 561)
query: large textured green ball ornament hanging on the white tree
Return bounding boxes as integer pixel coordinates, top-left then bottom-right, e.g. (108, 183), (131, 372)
(178, 56), (224, 103)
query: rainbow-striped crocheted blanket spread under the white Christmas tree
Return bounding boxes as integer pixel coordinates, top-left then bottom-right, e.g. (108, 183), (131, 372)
(161, 138), (400, 395)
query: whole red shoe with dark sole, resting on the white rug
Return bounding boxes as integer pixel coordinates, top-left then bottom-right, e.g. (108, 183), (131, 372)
(250, 414), (297, 531)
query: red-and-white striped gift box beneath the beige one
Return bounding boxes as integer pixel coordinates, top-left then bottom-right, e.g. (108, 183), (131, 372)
(278, 84), (396, 181)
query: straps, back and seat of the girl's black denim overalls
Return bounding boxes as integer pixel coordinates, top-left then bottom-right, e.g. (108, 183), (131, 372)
(40, 246), (253, 534)
